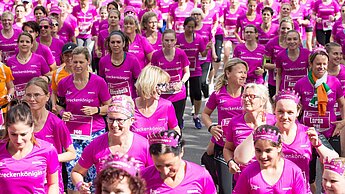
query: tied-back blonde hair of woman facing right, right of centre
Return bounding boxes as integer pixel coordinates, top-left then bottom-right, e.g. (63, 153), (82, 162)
(214, 58), (248, 91)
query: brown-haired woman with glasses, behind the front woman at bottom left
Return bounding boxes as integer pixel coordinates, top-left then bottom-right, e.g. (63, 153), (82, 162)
(24, 77), (76, 193)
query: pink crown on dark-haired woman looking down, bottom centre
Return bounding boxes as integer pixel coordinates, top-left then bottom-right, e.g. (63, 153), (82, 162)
(148, 131), (180, 147)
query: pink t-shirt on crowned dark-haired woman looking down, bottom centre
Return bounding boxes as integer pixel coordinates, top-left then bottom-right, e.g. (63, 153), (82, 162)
(140, 160), (217, 194)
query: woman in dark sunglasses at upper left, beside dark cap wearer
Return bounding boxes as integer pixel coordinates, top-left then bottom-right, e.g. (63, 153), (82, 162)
(37, 17), (64, 66)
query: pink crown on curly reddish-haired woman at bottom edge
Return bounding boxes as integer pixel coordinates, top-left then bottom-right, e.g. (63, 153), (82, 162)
(101, 153), (140, 176)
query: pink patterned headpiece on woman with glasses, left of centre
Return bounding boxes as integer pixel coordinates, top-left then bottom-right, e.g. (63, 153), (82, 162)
(108, 95), (134, 117)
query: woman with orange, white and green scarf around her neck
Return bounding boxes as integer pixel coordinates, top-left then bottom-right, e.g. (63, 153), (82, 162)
(295, 49), (345, 191)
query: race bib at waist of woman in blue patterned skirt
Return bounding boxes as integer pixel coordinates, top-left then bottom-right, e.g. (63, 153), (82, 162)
(65, 115), (93, 140)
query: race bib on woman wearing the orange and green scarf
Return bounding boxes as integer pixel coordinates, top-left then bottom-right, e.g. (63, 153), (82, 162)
(303, 111), (331, 132)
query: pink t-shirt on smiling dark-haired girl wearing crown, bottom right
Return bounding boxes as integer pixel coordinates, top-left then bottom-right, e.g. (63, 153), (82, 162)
(233, 158), (307, 194)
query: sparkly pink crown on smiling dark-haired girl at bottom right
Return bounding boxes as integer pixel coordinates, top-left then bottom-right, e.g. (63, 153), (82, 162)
(253, 125), (280, 143)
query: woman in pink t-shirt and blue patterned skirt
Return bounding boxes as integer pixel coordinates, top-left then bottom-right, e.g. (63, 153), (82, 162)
(57, 47), (111, 193)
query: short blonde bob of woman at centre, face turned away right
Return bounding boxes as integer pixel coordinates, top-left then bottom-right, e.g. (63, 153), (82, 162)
(135, 65), (170, 99)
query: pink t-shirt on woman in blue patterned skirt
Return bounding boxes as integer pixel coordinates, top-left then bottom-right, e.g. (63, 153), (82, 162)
(58, 73), (111, 132)
